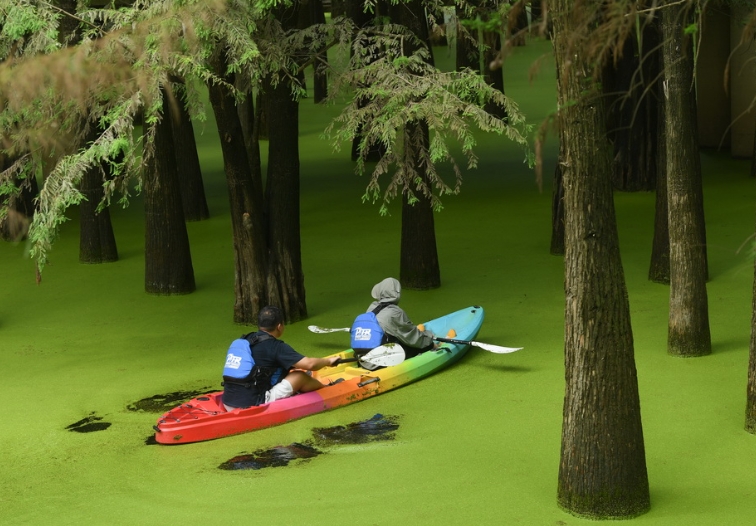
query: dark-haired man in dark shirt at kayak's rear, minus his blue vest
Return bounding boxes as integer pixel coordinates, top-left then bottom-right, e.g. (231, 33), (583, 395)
(223, 305), (339, 411)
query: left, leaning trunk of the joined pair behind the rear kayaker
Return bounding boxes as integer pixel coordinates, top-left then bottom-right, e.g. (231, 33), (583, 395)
(208, 48), (269, 324)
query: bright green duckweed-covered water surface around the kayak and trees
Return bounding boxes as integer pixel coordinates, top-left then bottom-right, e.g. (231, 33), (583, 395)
(0, 40), (756, 526)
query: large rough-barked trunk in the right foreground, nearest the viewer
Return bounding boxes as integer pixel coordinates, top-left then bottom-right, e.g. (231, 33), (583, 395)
(554, 0), (650, 519)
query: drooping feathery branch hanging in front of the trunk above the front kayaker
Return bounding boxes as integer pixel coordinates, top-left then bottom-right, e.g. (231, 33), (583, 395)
(324, 25), (533, 214)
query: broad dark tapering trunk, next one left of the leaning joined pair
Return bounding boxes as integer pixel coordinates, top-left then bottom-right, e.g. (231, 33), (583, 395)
(144, 91), (195, 294)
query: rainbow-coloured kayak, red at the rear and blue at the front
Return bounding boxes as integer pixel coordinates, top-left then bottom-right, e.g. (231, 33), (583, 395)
(153, 306), (484, 444)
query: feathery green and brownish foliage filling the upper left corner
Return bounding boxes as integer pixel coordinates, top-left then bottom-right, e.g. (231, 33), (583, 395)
(0, 0), (264, 270)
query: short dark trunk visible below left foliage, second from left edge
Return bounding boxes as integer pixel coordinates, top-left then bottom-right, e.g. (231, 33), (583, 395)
(79, 162), (118, 263)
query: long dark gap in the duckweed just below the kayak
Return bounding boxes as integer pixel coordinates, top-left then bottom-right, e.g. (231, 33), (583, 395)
(218, 414), (399, 470)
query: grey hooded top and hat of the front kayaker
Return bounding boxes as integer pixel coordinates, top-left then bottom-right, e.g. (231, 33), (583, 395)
(367, 278), (433, 349)
